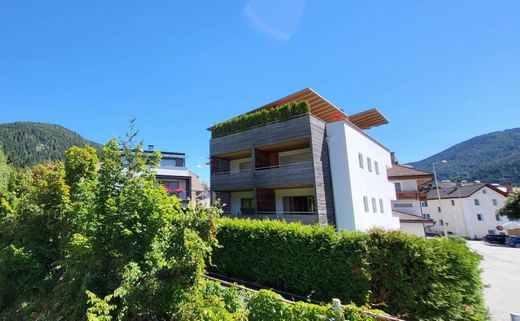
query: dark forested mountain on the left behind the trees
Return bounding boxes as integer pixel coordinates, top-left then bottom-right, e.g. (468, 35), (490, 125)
(0, 122), (101, 167)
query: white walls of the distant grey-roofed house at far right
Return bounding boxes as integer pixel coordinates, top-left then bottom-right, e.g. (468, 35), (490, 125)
(423, 187), (509, 238)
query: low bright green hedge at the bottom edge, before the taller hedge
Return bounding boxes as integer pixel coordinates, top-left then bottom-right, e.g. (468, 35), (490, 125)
(203, 282), (383, 321)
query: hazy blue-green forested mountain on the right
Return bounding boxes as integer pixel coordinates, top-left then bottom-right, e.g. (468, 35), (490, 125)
(410, 128), (520, 185)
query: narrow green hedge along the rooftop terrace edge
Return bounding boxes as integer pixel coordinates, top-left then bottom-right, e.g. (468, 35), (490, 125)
(211, 100), (310, 138)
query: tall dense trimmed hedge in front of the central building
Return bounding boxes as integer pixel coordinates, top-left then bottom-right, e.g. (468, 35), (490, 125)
(212, 218), (488, 320)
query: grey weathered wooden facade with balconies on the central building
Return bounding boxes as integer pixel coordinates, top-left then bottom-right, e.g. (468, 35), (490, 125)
(210, 114), (335, 226)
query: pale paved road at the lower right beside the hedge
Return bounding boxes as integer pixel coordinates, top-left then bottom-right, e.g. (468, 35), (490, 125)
(468, 241), (520, 321)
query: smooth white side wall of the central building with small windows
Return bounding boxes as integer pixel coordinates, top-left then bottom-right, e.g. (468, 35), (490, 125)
(326, 121), (399, 231)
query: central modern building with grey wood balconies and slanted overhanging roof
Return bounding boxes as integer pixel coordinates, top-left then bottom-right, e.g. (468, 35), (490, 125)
(209, 88), (399, 230)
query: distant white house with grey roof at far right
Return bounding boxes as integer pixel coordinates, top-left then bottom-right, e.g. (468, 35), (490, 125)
(420, 182), (511, 239)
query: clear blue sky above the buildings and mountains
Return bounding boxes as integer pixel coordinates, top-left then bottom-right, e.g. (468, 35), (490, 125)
(0, 0), (520, 178)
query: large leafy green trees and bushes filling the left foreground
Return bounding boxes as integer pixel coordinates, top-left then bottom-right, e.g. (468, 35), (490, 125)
(0, 134), (219, 320)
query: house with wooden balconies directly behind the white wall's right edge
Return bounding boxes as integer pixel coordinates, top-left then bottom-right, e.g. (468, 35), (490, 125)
(388, 162), (434, 236)
